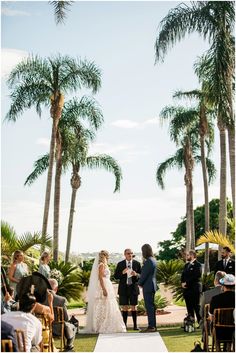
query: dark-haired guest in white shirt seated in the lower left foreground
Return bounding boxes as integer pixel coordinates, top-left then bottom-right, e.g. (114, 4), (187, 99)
(2, 293), (42, 352)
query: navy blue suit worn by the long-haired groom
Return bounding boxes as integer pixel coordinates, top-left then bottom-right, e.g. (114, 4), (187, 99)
(138, 257), (157, 328)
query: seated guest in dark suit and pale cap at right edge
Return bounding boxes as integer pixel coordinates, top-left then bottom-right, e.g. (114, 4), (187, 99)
(210, 274), (235, 340)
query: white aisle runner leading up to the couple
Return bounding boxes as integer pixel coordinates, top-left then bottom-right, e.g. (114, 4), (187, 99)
(94, 332), (168, 352)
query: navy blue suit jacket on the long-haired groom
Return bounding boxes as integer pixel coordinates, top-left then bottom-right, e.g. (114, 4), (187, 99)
(138, 257), (157, 293)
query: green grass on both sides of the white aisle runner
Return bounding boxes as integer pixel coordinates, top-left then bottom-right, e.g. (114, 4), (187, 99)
(54, 326), (201, 352)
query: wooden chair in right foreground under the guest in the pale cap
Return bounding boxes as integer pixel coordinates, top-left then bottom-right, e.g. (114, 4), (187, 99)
(212, 308), (235, 352)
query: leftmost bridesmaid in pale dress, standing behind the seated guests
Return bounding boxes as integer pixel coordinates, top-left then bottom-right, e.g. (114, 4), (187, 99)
(8, 250), (29, 295)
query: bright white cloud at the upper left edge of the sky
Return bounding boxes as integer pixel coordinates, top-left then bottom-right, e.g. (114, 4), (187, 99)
(1, 48), (29, 77)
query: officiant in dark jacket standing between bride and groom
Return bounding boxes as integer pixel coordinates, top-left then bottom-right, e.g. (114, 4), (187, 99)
(114, 249), (141, 330)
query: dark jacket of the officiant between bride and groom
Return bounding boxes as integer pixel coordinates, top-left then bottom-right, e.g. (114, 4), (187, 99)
(114, 260), (141, 296)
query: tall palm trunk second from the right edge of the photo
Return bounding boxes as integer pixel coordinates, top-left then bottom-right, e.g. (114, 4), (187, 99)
(218, 117), (227, 259)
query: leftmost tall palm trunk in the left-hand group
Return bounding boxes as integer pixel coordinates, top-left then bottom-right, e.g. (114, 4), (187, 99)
(41, 120), (57, 251)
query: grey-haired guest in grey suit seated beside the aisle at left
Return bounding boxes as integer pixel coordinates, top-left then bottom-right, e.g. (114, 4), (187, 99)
(49, 278), (76, 350)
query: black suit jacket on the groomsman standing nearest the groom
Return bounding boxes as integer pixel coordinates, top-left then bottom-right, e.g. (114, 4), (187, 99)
(181, 260), (202, 291)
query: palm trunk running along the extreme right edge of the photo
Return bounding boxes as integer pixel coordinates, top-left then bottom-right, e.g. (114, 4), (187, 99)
(228, 125), (235, 218)
